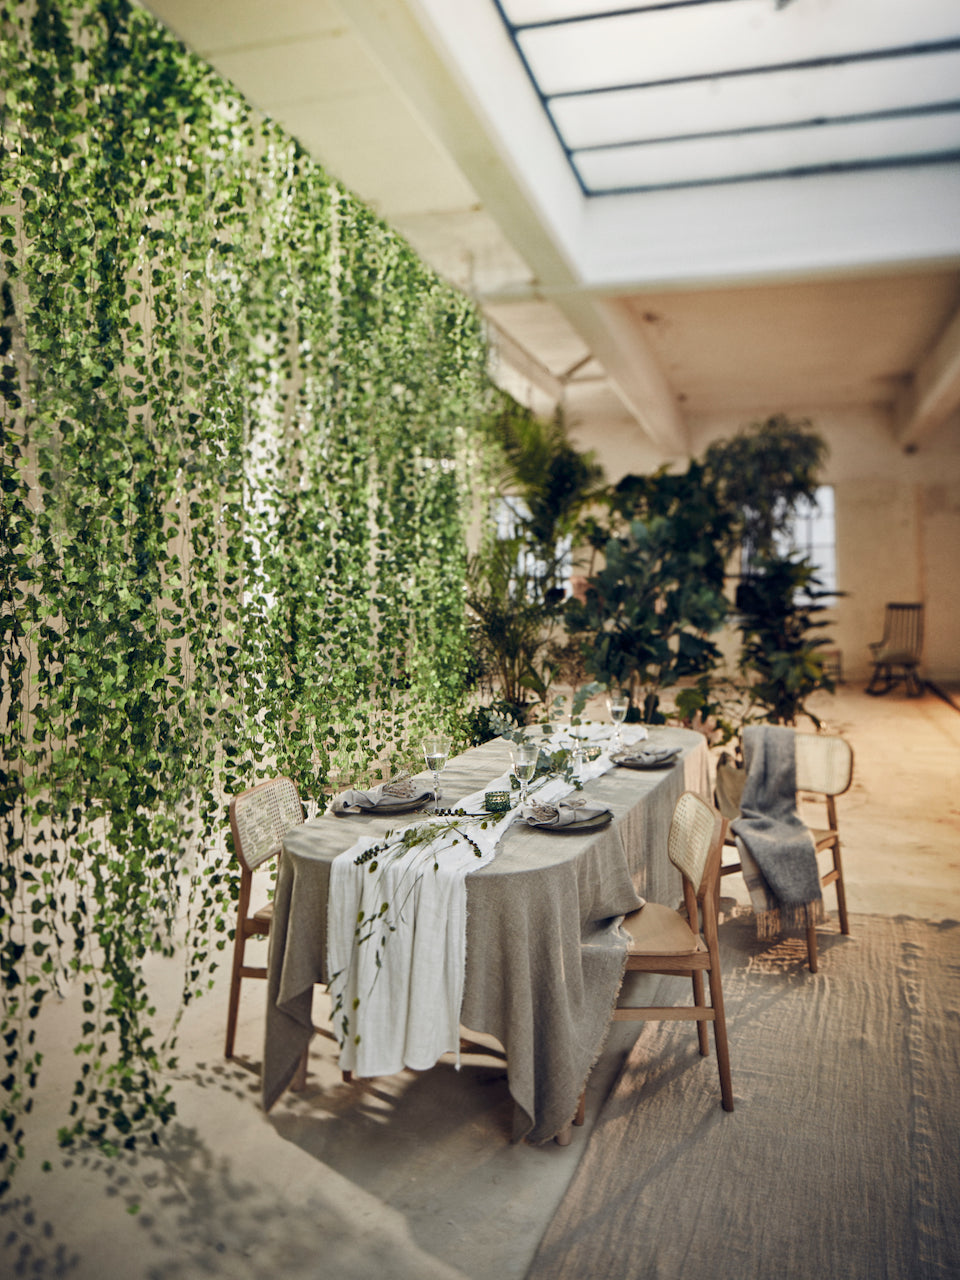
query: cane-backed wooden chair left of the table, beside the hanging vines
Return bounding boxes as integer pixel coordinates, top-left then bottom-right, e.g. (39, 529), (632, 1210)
(224, 777), (303, 1059)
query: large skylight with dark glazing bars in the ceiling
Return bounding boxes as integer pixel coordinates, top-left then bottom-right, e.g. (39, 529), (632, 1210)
(493, 0), (960, 196)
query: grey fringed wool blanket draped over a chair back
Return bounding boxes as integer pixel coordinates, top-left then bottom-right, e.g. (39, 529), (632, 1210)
(731, 724), (823, 938)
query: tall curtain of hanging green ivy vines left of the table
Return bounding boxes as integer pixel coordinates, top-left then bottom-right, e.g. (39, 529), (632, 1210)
(0, 0), (495, 1189)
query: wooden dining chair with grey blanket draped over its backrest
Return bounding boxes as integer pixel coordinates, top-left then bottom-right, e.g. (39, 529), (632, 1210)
(716, 731), (854, 973)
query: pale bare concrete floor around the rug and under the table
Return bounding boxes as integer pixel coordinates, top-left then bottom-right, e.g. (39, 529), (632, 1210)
(0, 686), (960, 1280)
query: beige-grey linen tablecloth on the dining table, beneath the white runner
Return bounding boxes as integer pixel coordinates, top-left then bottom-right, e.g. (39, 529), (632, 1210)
(262, 726), (710, 1143)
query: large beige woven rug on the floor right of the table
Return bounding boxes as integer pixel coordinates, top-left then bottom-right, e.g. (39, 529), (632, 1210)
(527, 914), (960, 1280)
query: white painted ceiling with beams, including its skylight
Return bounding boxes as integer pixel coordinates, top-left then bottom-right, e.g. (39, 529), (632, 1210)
(140, 0), (960, 456)
